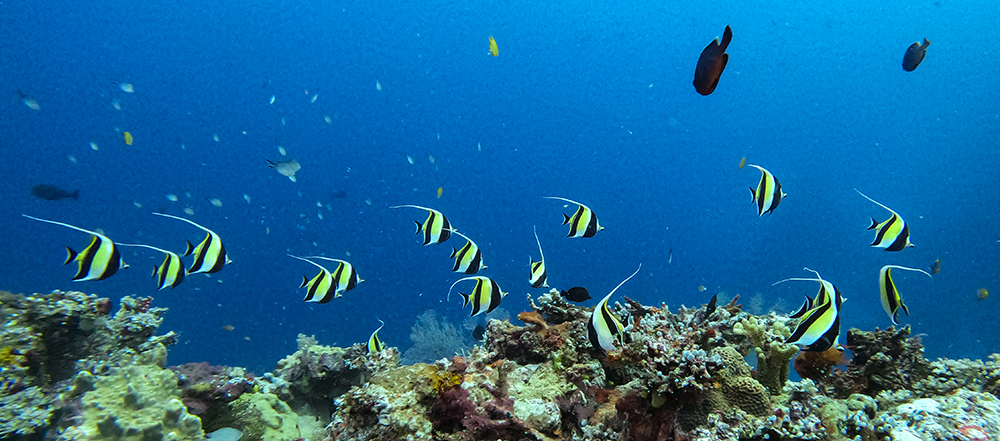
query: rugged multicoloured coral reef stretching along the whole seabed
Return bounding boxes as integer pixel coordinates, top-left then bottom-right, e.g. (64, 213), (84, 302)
(0, 290), (1000, 441)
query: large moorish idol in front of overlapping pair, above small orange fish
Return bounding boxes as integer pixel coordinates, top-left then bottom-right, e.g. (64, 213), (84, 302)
(772, 268), (846, 352)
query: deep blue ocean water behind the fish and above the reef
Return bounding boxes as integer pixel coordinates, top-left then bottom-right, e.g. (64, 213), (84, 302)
(0, 0), (1000, 371)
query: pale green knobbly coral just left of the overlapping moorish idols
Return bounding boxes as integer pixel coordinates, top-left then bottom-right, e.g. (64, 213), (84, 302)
(733, 315), (799, 395)
